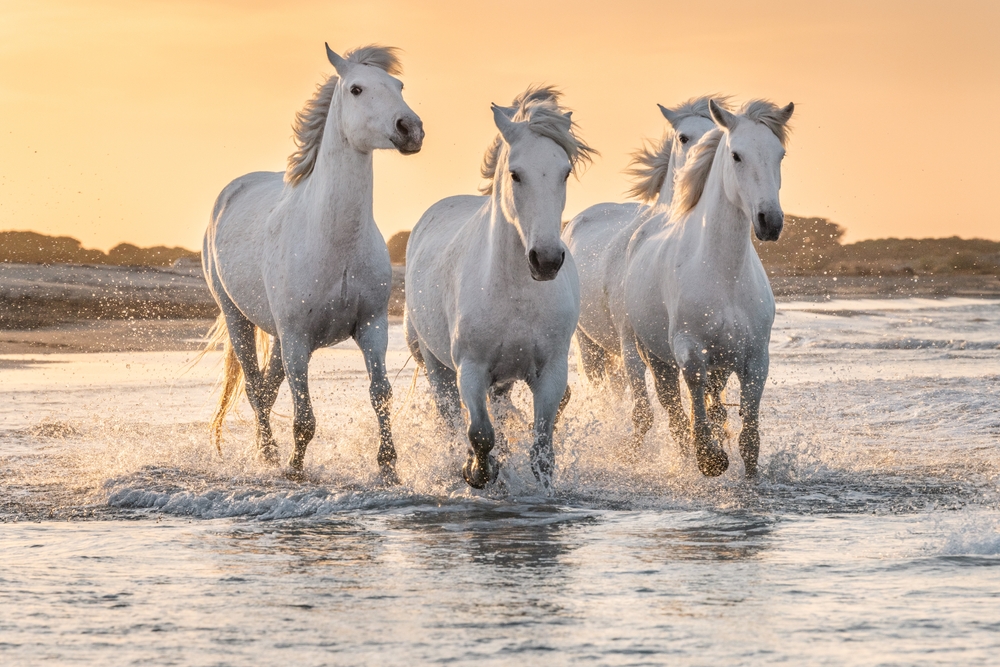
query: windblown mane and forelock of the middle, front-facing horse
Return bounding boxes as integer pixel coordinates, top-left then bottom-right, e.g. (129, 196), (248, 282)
(479, 86), (597, 195)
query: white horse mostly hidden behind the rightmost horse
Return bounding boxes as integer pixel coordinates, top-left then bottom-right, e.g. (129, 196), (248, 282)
(562, 97), (726, 446)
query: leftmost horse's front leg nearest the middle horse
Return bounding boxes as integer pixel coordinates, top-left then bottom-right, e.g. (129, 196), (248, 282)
(354, 315), (399, 484)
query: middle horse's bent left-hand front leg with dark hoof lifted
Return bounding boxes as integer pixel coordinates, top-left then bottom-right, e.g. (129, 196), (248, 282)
(458, 362), (499, 489)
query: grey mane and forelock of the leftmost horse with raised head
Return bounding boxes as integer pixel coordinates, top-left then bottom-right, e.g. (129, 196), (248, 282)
(285, 44), (403, 185)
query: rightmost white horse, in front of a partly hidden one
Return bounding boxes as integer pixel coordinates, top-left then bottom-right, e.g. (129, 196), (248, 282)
(625, 100), (794, 477)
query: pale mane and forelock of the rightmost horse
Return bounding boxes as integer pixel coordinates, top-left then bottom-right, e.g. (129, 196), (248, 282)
(673, 100), (788, 215)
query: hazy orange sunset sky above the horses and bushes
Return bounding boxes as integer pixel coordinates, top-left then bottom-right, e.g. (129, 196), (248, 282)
(0, 0), (1000, 249)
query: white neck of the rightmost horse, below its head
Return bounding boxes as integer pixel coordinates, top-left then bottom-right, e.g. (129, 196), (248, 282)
(686, 141), (754, 276)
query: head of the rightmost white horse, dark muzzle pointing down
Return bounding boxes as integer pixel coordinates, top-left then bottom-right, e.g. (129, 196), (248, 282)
(709, 100), (795, 241)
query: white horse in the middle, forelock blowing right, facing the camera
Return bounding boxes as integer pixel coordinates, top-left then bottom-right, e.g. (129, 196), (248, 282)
(406, 88), (593, 488)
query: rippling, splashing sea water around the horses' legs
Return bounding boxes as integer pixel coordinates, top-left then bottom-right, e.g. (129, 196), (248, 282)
(0, 299), (1000, 665)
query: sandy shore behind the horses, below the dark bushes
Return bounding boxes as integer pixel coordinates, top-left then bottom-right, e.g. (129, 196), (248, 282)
(0, 263), (1000, 358)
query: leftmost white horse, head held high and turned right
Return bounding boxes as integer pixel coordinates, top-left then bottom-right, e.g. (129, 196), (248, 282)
(202, 45), (424, 481)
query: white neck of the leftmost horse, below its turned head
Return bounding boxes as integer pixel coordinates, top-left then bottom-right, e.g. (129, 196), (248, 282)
(302, 100), (375, 246)
